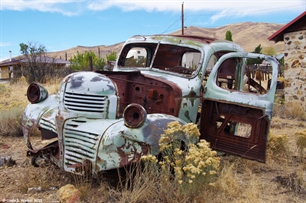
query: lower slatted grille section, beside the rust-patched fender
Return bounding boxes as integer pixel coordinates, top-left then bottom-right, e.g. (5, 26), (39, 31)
(64, 124), (98, 166)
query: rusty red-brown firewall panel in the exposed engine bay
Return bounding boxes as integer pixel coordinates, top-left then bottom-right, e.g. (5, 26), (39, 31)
(106, 71), (182, 117)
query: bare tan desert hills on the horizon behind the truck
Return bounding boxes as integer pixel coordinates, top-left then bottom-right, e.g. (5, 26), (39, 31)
(49, 22), (284, 59)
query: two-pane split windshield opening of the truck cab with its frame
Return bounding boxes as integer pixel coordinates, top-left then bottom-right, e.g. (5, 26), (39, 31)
(117, 41), (204, 78)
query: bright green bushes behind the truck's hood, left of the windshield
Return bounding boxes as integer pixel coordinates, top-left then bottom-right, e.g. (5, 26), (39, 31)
(69, 51), (106, 71)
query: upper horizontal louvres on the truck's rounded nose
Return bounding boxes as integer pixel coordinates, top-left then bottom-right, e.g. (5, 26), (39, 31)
(64, 92), (107, 113)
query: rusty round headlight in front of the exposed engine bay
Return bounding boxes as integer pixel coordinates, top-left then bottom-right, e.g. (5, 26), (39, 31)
(123, 104), (147, 128)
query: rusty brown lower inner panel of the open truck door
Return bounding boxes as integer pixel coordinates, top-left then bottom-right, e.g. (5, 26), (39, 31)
(200, 100), (269, 162)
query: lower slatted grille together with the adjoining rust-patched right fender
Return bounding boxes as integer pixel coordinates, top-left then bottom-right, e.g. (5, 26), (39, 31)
(63, 114), (185, 174)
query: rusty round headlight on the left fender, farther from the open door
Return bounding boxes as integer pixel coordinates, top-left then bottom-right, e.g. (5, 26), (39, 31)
(27, 83), (48, 104)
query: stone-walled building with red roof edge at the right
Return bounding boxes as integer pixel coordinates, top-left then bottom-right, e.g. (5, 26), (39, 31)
(268, 11), (306, 111)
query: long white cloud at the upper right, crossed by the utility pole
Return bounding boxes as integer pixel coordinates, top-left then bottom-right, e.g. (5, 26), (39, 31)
(88, 0), (305, 13)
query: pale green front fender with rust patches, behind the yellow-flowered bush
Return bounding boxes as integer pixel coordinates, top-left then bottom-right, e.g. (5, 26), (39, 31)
(97, 114), (186, 170)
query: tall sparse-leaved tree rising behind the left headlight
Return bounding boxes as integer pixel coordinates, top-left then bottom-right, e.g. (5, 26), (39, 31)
(19, 42), (54, 83)
